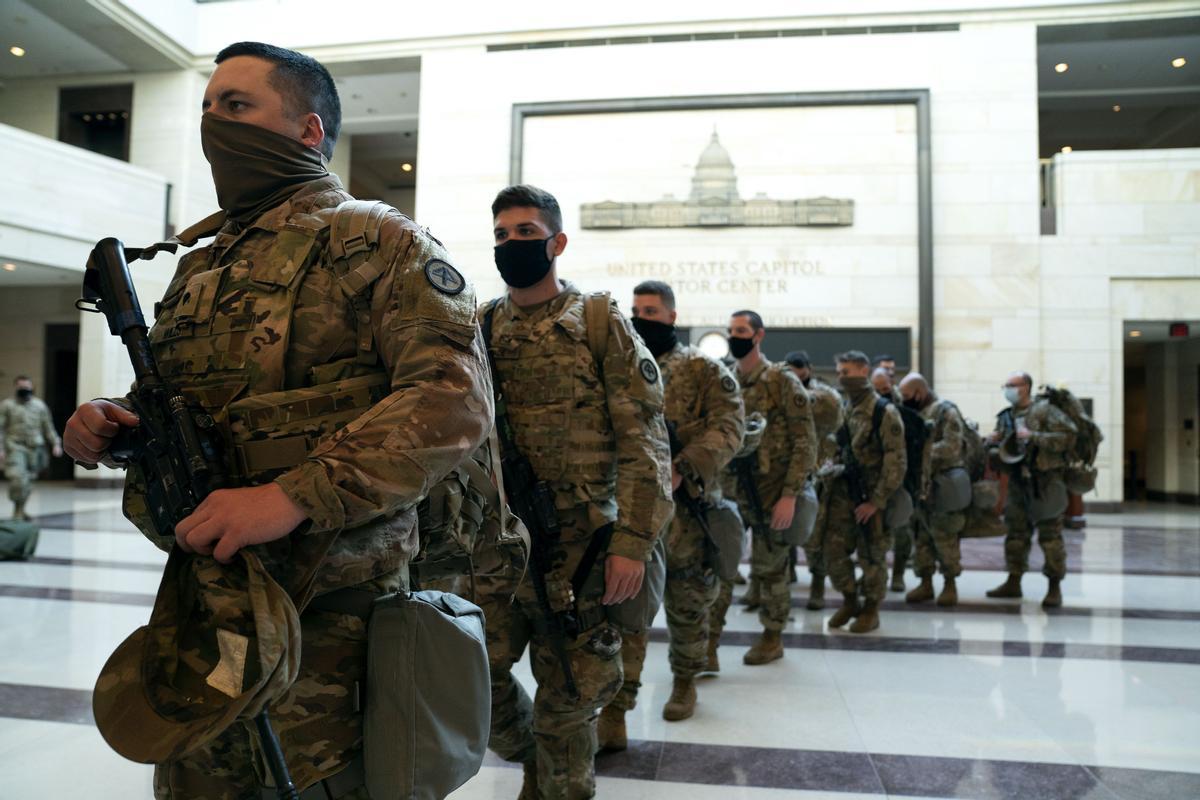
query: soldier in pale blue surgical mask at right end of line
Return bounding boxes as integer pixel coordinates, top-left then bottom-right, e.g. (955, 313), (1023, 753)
(988, 372), (1076, 608)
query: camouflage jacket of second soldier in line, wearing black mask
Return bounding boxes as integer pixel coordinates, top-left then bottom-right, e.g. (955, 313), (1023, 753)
(479, 281), (674, 561)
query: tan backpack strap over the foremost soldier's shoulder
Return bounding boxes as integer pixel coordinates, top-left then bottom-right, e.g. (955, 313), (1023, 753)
(329, 200), (391, 366)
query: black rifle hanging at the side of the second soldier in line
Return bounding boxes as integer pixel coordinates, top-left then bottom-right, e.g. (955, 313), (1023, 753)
(484, 303), (585, 700)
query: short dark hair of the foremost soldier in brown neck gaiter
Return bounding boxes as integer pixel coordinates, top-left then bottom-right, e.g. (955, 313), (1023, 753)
(212, 42), (342, 158)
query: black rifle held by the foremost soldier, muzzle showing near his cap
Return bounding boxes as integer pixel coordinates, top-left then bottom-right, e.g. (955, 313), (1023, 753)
(76, 237), (300, 800)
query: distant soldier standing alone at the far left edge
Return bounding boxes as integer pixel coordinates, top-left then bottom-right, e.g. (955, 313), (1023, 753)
(0, 375), (62, 519)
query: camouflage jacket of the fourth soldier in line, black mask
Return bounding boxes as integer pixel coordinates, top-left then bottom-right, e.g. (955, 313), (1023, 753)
(738, 357), (817, 509)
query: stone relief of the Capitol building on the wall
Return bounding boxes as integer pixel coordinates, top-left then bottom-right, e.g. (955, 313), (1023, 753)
(580, 131), (854, 229)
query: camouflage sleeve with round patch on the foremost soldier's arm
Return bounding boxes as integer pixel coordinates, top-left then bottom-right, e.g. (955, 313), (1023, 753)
(276, 221), (493, 530)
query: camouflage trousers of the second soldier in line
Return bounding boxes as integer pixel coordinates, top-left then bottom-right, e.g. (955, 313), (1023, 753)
(476, 524), (622, 800)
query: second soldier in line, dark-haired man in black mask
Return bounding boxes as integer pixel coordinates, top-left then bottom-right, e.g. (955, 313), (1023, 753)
(480, 186), (672, 798)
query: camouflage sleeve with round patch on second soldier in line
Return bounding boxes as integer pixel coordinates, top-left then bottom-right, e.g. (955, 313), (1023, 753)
(604, 301), (674, 561)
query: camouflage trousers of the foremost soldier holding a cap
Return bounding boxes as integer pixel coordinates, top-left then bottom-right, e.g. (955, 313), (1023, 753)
(154, 569), (407, 800)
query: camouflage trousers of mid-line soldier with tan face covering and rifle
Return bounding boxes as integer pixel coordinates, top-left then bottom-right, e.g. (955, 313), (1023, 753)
(823, 481), (892, 602)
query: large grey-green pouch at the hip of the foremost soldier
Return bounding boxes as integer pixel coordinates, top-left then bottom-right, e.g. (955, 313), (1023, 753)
(362, 591), (492, 800)
